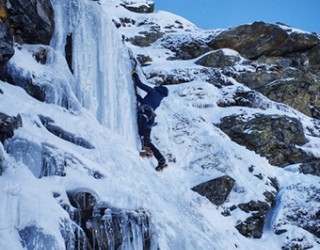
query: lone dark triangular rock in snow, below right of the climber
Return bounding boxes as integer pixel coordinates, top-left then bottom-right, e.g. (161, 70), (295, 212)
(192, 175), (236, 205)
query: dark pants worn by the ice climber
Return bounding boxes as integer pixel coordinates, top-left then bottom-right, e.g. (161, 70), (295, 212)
(138, 113), (165, 164)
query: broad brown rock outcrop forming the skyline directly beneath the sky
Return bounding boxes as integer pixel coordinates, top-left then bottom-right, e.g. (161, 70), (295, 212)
(208, 22), (320, 59)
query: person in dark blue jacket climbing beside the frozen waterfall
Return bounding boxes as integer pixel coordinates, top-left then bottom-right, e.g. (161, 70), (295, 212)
(131, 70), (169, 171)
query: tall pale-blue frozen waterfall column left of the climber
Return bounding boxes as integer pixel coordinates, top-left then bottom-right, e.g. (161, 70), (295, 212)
(52, 0), (136, 143)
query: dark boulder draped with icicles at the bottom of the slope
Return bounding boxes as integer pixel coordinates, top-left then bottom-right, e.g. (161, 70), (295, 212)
(66, 190), (157, 250)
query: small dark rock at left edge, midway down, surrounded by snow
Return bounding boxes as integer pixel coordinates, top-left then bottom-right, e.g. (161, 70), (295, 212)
(0, 113), (22, 144)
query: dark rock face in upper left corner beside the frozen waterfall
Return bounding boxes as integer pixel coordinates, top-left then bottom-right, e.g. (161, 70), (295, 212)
(0, 0), (58, 107)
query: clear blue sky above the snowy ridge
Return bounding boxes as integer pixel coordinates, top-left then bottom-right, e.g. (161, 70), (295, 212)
(154, 0), (320, 35)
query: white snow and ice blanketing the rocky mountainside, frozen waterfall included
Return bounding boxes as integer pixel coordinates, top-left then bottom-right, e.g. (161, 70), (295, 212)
(0, 0), (320, 250)
